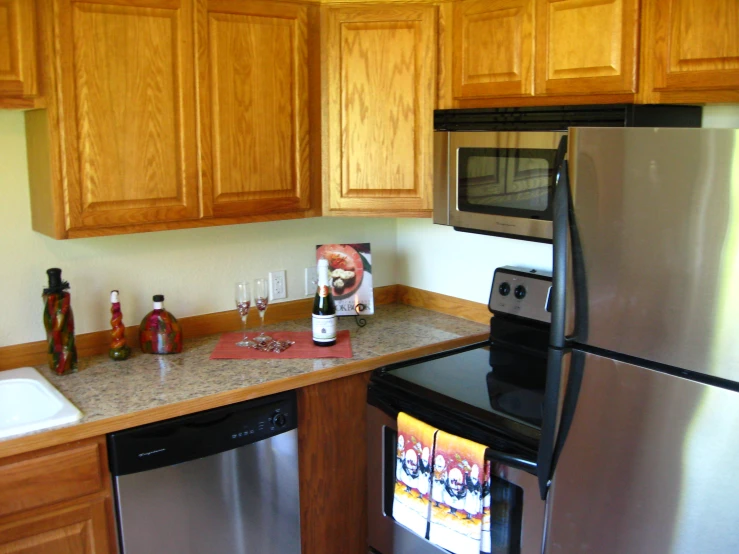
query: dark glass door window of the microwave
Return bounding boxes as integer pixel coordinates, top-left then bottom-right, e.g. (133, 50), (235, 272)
(457, 147), (557, 220)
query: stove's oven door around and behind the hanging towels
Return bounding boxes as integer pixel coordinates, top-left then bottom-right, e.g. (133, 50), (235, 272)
(367, 404), (544, 554)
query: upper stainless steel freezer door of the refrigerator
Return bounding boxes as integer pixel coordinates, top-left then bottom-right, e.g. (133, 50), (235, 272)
(566, 128), (739, 381)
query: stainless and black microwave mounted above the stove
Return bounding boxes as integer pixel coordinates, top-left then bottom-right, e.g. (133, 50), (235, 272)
(434, 104), (702, 242)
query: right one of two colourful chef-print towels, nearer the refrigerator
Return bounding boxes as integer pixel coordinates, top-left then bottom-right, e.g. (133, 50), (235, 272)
(429, 431), (486, 554)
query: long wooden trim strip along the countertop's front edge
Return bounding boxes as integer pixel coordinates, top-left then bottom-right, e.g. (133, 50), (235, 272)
(0, 332), (488, 458)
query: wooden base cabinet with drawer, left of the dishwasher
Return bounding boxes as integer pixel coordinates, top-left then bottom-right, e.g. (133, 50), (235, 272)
(0, 438), (117, 554)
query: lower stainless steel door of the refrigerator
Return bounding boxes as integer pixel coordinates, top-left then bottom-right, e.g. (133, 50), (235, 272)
(545, 354), (739, 554)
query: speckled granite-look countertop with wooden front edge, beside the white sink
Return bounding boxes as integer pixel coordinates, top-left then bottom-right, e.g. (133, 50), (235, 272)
(0, 304), (489, 457)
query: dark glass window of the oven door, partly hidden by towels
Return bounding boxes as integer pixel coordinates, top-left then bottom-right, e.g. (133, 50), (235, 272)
(383, 427), (523, 554)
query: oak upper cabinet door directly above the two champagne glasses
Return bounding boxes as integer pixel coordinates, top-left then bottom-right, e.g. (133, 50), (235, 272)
(199, 0), (310, 217)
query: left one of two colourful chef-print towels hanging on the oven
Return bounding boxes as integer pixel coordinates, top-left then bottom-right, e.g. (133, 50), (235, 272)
(392, 412), (436, 537)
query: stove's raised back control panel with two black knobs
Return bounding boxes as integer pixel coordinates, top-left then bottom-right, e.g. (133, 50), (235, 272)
(488, 266), (552, 323)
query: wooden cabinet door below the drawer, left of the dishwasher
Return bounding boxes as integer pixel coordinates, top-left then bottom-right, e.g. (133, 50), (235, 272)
(0, 499), (115, 554)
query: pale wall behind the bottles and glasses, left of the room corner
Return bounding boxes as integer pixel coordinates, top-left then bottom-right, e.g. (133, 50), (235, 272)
(0, 110), (396, 346)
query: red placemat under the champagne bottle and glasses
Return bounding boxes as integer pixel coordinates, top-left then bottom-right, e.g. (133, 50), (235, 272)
(210, 330), (352, 360)
